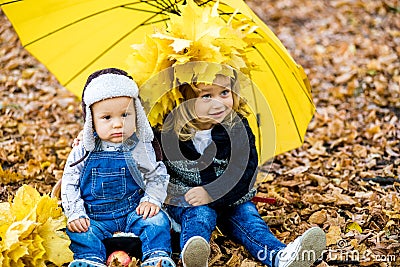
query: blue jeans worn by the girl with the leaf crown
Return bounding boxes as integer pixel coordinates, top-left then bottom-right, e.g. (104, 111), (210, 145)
(167, 201), (286, 266)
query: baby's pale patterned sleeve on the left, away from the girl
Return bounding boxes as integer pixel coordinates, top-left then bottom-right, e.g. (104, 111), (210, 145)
(61, 142), (89, 223)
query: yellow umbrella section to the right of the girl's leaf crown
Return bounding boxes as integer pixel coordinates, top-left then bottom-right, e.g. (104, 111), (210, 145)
(219, 1), (315, 157)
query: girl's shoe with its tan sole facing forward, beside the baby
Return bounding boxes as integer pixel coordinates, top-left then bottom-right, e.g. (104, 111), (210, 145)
(182, 236), (210, 267)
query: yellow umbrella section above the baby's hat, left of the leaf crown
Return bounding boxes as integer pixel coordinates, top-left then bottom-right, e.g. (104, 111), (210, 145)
(3, 0), (168, 96)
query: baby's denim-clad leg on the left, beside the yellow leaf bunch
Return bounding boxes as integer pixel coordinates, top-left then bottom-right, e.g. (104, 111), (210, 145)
(67, 220), (112, 264)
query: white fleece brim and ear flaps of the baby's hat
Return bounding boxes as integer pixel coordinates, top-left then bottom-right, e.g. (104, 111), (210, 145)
(82, 73), (154, 151)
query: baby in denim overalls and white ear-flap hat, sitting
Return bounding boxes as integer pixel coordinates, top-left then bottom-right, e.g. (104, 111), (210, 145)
(61, 68), (175, 267)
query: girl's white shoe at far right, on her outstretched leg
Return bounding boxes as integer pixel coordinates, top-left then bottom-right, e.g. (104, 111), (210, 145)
(275, 227), (326, 267)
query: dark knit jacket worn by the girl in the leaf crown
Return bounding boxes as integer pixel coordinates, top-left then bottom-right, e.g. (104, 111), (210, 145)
(155, 117), (258, 208)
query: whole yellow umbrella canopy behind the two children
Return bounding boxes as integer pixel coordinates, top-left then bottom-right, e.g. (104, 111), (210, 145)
(0, 0), (315, 163)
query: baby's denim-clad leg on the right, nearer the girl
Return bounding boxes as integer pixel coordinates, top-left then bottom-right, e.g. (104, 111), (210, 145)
(125, 210), (172, 261)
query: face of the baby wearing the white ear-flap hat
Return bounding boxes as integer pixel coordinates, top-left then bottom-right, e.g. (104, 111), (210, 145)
(92, 96), (136, 143)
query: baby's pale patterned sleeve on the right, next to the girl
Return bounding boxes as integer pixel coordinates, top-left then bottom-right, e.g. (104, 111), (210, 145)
(133, 142), (169, 207)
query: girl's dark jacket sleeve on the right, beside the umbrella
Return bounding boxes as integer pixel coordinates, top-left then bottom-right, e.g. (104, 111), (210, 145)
(204, 118), (258, 208)
